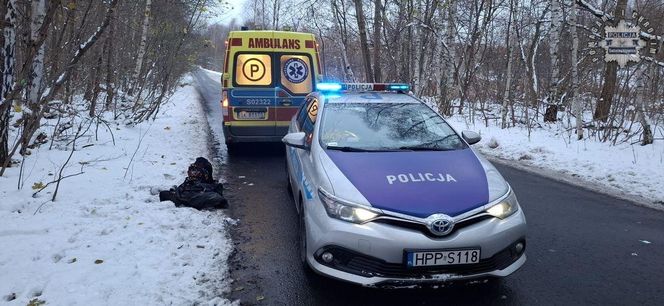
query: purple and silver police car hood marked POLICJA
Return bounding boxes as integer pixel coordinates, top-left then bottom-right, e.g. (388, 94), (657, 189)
(325, 148), (507, 218)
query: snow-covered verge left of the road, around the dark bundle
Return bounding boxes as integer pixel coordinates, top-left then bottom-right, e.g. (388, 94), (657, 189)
(0, 75), (233, 305)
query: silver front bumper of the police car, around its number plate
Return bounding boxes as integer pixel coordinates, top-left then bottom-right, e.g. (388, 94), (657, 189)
(307, 206), (526, 287)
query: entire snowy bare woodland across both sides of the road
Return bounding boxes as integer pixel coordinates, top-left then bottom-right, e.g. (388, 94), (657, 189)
(0, 0), (664, 176)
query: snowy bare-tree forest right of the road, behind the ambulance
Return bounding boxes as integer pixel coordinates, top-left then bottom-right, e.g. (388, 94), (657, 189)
(201, 0), (664, 145)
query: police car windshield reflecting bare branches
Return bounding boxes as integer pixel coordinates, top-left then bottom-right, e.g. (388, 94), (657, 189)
(319, 103), (466, 152)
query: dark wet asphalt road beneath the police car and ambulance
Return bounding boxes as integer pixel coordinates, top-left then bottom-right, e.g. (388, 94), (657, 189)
(195, 72), (664, 305)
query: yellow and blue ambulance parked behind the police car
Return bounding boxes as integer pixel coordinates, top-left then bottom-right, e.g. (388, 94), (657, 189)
(221, 30), (322, 154)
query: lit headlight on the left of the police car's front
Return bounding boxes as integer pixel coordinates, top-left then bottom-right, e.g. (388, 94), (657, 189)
(318, 189), (379, 224)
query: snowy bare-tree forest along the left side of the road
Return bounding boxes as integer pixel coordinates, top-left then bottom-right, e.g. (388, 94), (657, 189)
(0, 0), (218, 176)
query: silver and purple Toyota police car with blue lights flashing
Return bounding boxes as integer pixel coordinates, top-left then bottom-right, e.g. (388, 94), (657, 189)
(283, 83), (526, 287)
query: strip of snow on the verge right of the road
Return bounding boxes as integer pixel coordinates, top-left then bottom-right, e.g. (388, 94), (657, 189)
(447, 115), (664, 209)
